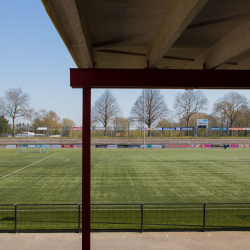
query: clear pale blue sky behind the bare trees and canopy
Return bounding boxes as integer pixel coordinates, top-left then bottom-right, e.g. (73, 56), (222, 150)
(0, 0), (250, 126)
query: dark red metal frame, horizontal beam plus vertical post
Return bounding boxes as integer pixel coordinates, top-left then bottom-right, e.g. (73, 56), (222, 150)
(70, 69), (250, 249)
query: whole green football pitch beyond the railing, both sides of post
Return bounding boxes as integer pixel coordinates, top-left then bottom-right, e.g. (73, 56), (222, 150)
(0, 149), (250, 204)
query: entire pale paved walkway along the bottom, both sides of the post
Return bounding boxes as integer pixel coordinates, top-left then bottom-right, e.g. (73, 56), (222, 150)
(0, 232), (250, 250)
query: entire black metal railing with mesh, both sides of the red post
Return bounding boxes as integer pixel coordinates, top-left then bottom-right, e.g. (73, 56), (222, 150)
(0, 203), (250, 233)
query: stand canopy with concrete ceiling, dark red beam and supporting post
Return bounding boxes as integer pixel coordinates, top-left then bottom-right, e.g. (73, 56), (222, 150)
(42, 0), (250, 249)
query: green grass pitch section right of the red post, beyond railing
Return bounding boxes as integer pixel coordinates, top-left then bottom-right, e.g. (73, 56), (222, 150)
(91, 148), (250, 203)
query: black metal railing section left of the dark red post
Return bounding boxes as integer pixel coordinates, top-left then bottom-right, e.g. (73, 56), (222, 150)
(0, 204), (82, 233)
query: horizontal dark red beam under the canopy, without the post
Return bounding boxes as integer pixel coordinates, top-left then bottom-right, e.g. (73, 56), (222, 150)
(70, 69), (250, 89)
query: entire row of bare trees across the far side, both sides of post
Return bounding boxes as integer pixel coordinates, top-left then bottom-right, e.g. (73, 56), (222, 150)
(0, 88), (250, 136)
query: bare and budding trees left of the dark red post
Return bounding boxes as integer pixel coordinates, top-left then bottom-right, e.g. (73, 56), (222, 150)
(0, 88), (76, 136)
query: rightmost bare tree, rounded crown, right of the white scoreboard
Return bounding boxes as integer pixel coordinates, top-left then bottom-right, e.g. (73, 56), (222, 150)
(213, 92), (248, 127)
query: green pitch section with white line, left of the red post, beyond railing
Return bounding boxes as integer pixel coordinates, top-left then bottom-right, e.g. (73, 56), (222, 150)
(0, 149), (82, 204)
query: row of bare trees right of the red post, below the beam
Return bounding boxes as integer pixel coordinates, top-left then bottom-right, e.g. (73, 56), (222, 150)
(91, 89), (250, 135)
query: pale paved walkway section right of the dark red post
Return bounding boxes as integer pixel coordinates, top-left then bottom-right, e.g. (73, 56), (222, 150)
(91, 232), (250, 250)
